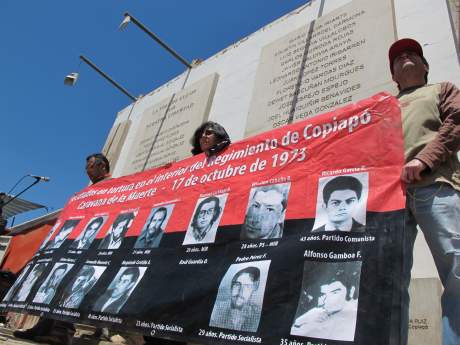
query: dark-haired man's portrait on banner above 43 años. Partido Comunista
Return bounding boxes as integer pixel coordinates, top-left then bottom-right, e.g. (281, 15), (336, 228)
(312, 172), (369, 232)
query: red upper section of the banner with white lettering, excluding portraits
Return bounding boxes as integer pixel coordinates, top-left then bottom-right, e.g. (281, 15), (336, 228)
(61, 94), (404, 239)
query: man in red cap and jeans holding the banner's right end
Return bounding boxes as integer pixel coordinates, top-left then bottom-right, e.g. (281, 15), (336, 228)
(388, 38), (460, 345)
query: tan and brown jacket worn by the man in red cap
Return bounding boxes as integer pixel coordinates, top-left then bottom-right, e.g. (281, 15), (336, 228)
(398, 82), (460, 191)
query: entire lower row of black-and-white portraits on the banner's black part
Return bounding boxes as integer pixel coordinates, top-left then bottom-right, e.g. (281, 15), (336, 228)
(4, 260), (361, 341)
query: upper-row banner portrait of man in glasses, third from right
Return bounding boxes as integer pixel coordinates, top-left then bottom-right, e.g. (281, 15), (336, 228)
(182, 194), (228, 245)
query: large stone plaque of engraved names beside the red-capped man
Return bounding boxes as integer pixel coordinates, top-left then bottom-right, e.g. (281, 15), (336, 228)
(245, 0), (396, 136)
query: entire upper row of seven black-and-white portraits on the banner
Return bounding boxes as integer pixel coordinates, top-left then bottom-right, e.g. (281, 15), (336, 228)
(37, 172), (369, 250)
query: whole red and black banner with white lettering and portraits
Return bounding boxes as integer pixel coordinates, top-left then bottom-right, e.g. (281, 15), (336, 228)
(1, 93), (405, 345)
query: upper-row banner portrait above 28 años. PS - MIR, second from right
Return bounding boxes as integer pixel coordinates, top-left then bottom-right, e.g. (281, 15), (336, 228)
(241, 183), (291, 240)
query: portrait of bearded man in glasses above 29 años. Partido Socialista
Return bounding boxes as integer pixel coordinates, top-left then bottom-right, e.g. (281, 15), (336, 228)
(209, 260), (270, 332)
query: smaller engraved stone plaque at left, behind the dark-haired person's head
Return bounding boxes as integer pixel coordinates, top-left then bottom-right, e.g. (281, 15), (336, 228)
(122, 73), (218, 175)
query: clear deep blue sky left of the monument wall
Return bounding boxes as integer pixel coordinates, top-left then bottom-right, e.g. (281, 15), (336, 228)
(0, 0), (307, 224)
